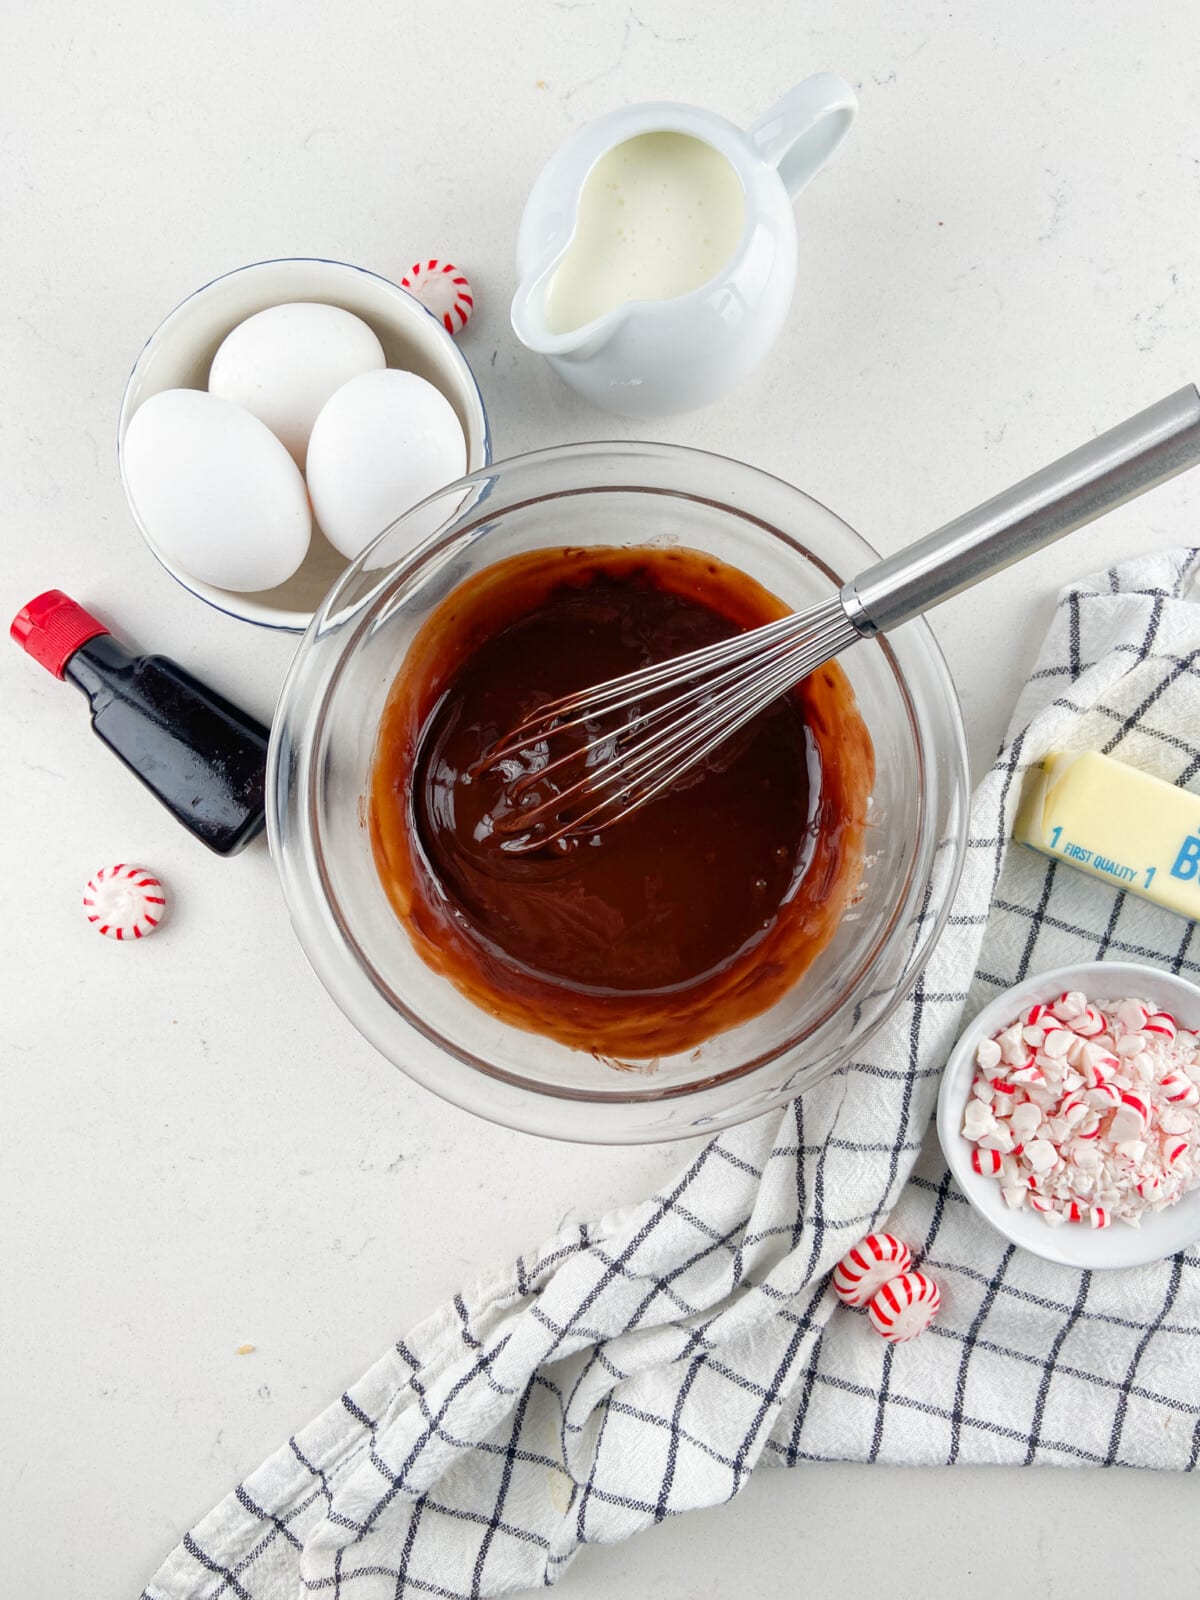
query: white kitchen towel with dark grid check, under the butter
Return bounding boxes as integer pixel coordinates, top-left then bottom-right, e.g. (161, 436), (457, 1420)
(146, 550), (1200, 1600)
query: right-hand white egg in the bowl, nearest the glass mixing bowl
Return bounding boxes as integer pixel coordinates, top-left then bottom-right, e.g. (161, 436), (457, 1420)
(307, 368), (467, 557)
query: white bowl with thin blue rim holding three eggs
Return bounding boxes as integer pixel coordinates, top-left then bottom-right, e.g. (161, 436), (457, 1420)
(117, 256), (491, 634)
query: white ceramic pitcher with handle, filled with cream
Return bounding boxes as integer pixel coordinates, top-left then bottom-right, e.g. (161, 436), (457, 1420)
(512, 72), (858, 418)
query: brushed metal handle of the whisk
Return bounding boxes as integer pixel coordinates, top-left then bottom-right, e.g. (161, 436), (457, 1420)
(842, 384), (1200, 634)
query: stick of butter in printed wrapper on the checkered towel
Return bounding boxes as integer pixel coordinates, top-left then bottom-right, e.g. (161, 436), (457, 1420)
(1013, 750), (1200, 922)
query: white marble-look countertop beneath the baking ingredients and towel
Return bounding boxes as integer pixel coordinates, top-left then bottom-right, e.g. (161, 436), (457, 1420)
(0, 0), (1200, 1600)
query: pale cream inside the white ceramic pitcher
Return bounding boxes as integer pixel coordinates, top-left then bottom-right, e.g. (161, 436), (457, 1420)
(546, 133), (746, 333)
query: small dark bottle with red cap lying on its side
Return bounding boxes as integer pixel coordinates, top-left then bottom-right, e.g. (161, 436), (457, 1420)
(11, 589), (269, 856)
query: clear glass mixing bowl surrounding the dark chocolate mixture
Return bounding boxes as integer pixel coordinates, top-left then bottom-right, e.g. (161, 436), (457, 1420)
(267, 443), (968, 1144)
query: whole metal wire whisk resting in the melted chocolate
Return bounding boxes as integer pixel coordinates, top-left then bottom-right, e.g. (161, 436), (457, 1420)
(483, 384), (1200, 853)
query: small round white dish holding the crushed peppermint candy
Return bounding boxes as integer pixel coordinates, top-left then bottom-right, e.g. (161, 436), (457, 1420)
(938, 962), (1200, 1270)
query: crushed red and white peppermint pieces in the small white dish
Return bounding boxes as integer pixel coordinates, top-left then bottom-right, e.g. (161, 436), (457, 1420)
(963, 990), (1200, 1227)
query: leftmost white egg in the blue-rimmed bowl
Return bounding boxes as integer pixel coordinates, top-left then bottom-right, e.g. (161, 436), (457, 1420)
(123, 389), (312, 592)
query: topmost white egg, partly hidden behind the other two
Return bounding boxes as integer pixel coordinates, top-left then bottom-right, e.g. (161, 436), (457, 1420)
(208, 304), (387, 470)
